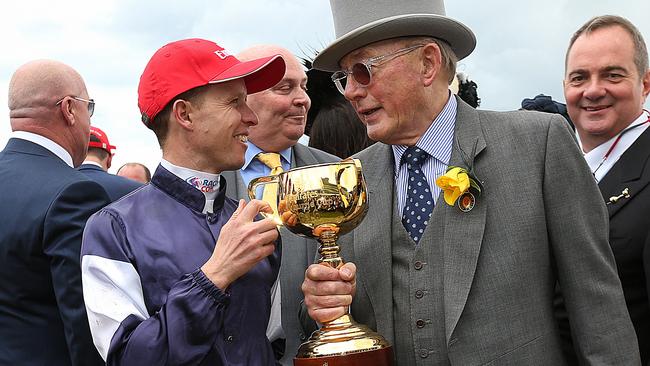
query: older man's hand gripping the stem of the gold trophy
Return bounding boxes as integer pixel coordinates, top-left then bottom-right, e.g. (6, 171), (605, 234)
(302, 263), (357, 323)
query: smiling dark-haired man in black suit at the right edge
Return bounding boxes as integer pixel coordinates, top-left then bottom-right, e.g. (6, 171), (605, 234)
(560, 16), (650, 365)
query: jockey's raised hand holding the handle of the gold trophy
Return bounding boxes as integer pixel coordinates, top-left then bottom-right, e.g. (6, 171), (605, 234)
(201, 200), (278, 290)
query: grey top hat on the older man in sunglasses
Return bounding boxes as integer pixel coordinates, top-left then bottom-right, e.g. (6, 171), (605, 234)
(313, 0), (476, 71)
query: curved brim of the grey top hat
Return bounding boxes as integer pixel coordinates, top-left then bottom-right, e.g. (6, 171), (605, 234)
(313, 14), (476, 71)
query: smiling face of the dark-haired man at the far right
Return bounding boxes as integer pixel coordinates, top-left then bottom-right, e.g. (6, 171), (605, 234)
(564, 26), (650, 152)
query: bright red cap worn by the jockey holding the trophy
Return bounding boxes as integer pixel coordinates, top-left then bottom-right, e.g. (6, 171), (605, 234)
(138, 38), (285, 127)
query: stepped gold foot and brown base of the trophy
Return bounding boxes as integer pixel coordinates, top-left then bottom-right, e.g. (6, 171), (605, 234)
(293, 314), (393, 366)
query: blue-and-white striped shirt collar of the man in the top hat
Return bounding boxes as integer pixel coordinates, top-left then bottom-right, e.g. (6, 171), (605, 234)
(392, 92), (458, 174)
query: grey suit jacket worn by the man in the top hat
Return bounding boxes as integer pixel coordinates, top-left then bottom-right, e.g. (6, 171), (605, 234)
(339, 101), (640, 366)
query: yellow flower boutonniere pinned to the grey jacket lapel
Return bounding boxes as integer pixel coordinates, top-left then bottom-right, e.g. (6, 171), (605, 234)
(436, 166), (481, 212)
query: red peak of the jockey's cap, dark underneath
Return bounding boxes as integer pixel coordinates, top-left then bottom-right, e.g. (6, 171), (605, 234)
(210, 55), (286, 94)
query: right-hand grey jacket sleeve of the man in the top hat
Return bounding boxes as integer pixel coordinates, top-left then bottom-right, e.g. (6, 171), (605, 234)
(543, 116), (641, 365)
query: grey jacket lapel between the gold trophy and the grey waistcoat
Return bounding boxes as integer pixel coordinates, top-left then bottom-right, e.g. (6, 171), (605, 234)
(352, 143), (394, 338)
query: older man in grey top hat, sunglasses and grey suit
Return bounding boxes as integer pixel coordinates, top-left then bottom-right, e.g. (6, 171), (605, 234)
(303, 0), (639, 365)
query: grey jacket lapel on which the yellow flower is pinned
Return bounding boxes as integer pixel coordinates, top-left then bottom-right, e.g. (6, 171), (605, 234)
(440, 98), (490, 341)
